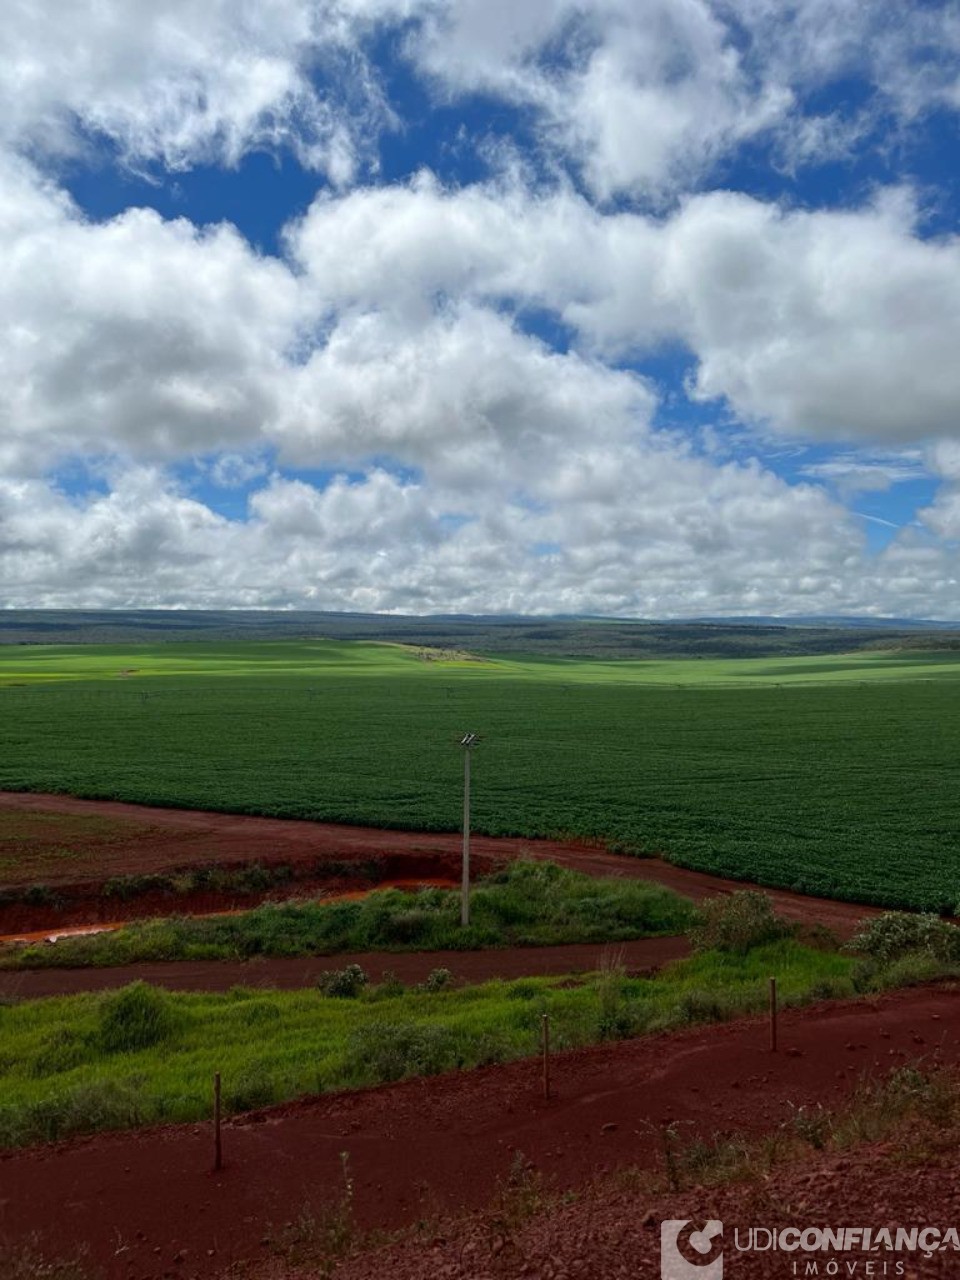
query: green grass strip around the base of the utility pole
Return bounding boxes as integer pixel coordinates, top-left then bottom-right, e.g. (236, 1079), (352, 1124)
(0, 861), (692, 969)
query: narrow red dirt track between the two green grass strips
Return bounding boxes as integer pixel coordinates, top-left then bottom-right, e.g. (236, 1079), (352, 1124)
(0, 938), (690, 1000)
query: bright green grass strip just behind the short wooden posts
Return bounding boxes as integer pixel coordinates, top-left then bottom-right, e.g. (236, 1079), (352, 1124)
(0, 940), (854, 1146)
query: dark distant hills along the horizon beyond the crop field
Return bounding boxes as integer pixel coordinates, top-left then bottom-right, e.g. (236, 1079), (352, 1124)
(0, 609), (960, 659)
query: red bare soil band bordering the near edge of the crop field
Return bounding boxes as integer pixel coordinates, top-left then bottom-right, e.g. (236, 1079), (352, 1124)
(0, 792), (877, 936)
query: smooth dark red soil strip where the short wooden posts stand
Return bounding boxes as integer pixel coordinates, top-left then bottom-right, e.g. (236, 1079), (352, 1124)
(0, 988), (960, 1280)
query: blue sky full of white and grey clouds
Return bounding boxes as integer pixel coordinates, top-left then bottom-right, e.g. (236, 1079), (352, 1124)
(0, 0), (960, 620)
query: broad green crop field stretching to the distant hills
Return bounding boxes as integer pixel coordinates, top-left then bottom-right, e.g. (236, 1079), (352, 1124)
(0, 640), (960, 910)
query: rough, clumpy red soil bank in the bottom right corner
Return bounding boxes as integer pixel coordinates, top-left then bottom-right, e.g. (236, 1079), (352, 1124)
(335, 1126), (960, 1280)
